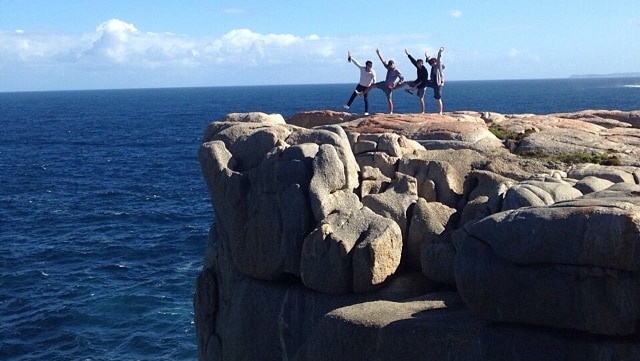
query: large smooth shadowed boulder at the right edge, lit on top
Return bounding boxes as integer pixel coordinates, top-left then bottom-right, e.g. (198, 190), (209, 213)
(455, 198), (640, 335)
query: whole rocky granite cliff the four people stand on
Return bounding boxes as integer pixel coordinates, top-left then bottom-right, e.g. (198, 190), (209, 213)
(194, 110), (640, 361)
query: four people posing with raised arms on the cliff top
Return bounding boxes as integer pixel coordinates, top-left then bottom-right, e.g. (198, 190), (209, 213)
(344, 47), (444, 115)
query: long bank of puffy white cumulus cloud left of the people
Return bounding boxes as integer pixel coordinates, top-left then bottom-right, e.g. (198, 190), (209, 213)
(0, 19), (339, 68)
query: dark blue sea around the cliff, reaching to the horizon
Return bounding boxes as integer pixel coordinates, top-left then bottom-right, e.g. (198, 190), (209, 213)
(0, 78), (640, 361)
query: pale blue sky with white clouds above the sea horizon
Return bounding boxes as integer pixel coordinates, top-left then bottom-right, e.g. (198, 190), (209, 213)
(0, 0), (640, 91)
